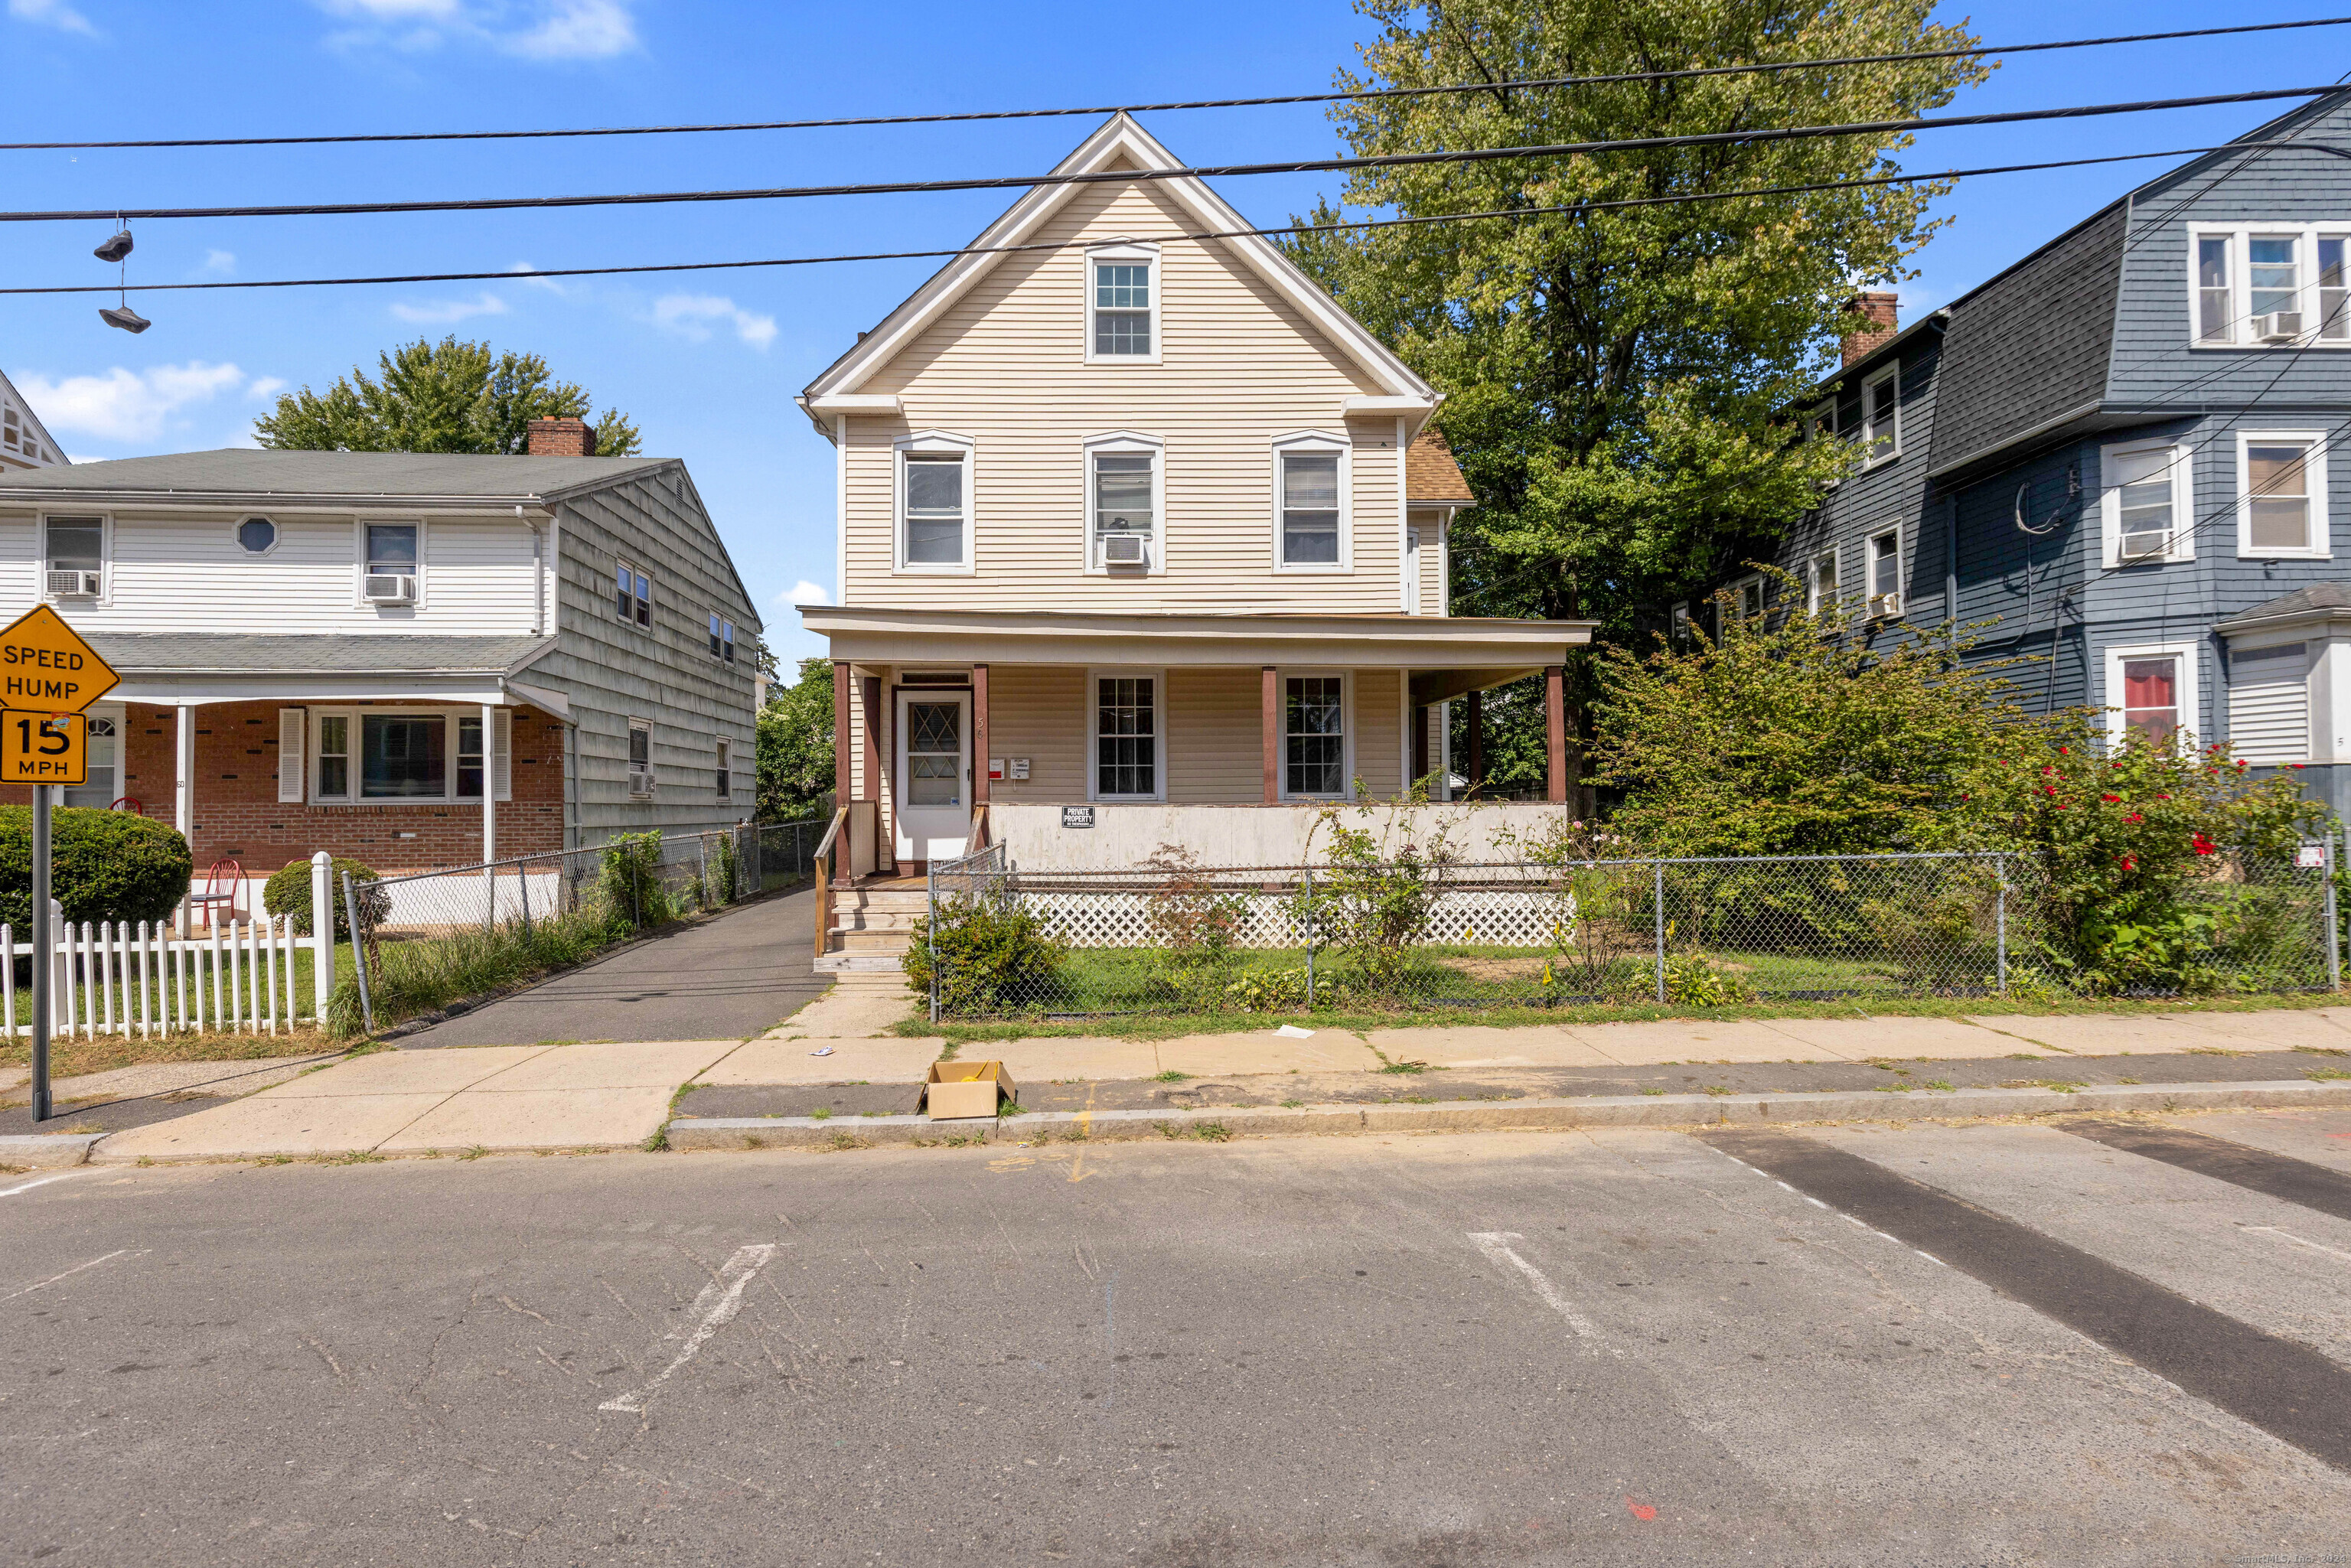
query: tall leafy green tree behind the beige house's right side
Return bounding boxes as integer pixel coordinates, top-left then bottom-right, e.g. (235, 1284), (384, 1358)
(1293, 0), (1987, 799)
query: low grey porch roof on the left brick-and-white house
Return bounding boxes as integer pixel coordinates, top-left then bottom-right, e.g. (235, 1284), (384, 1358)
(90, 632), (566, 712)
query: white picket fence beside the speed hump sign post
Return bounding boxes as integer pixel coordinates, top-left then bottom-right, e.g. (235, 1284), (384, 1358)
(0, 914), (318, 1039)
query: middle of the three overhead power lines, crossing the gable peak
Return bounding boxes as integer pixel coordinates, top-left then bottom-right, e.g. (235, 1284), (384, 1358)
(0, 83), (2344, 223)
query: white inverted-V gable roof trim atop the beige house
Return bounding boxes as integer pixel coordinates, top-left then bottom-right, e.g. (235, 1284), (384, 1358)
(802, 112), (1439, 435)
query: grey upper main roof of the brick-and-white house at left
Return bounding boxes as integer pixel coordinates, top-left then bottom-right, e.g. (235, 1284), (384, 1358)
(0, 447), (682, 503)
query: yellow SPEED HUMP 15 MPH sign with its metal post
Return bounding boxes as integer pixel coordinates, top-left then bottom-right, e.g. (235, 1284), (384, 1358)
(0, 604), (122, 1126)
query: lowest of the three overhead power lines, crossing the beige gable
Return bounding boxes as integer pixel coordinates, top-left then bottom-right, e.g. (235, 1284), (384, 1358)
(0, 141), (2266, 296)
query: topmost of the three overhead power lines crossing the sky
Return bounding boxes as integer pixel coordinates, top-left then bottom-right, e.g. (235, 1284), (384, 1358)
(0, 17), (2351, 153)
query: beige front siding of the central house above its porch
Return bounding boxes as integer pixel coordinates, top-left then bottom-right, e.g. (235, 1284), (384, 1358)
(844, 171), (1401, 614)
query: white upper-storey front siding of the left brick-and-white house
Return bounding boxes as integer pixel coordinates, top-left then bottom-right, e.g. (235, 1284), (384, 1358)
(0, 508), (533, 634)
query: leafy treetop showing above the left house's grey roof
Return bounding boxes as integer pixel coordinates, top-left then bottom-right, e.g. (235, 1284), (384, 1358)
(254, 334), (642, 456)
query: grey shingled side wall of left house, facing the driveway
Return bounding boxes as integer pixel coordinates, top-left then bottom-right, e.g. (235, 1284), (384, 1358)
(524, 468), (759, 846)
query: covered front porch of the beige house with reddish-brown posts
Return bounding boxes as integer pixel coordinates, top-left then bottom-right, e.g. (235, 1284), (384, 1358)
(804, 607), (1592, 886)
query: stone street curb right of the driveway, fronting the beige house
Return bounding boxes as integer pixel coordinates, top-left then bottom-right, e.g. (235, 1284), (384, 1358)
(670, 1079), (2351, 1149)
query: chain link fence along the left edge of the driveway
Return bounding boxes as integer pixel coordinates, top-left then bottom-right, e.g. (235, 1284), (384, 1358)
(329, 823), (823, 1035)
